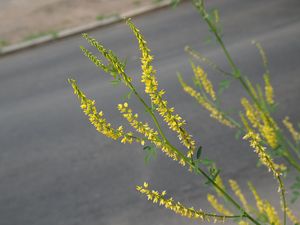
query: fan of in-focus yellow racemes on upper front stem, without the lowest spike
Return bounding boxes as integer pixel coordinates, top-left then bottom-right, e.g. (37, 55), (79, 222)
(69, 20), (195, 165)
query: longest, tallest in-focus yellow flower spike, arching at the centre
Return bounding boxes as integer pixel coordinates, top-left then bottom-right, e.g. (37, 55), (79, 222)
(127, 20), (196, 157)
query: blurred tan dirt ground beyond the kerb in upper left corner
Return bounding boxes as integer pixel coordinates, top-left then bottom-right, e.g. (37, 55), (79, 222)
(0, 0), (155, 47)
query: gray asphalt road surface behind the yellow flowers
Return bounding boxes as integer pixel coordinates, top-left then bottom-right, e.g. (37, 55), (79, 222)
(0, 0), (300, 225)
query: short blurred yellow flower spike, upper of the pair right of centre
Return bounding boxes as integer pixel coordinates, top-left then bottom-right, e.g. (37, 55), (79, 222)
(192, 64), (216, 101)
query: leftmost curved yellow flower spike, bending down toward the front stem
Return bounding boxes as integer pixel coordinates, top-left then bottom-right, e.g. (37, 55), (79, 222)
(69, 79), (142, 143)
